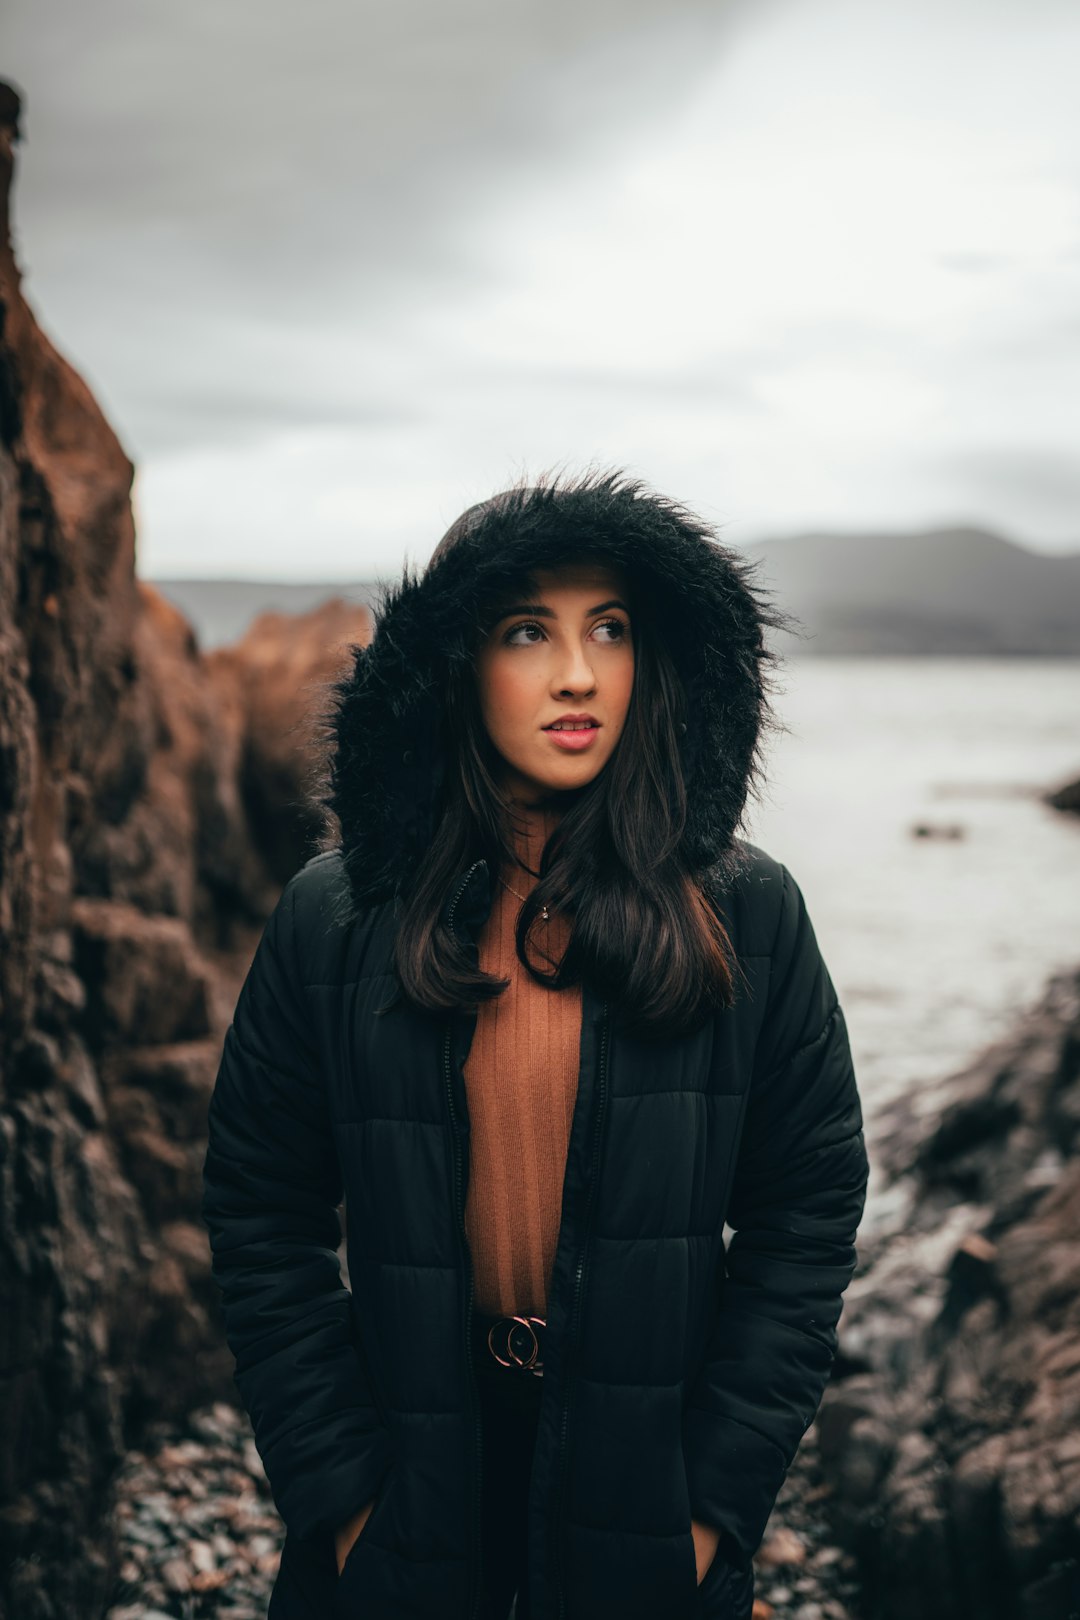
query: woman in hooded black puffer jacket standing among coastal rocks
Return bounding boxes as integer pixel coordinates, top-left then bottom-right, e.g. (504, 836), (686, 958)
(204, 475), (866, 1620)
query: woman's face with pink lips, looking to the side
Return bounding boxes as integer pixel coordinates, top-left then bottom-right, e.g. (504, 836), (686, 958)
(476, 562), (633, 802)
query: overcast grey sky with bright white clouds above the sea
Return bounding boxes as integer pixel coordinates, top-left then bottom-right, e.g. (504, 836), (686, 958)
(3, 0), (1080, 580)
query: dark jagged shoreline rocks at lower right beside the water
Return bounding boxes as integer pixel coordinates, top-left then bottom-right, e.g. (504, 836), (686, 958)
(818, 972), (1080, 1620)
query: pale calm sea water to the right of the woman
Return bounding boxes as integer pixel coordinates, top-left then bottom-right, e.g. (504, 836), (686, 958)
(743, 656), (1080, 1124)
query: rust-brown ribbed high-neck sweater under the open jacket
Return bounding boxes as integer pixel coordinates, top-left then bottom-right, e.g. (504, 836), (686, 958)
(463, 810), (581, 1317)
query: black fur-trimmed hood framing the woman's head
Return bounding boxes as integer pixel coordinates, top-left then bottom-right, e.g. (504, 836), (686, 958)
(319, 473), (792, 909)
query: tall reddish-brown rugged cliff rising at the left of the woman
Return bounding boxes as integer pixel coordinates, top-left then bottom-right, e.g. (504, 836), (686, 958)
(0, 86), (369, 1620)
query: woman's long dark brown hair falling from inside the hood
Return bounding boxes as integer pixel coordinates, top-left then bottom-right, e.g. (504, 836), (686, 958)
(395, 518), (757, 1038)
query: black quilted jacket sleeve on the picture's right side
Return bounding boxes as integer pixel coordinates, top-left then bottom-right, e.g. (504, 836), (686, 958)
(683, 867), (868, 1567)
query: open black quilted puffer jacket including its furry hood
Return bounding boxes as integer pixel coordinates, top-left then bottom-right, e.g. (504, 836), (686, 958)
(204, 479), (868, 1620)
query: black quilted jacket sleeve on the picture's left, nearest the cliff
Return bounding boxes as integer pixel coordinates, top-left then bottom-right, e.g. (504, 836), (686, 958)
(202, 873), (392, 1537)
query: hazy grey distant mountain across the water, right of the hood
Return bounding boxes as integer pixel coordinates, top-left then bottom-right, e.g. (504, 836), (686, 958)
(745, 528), (1080, 656)
